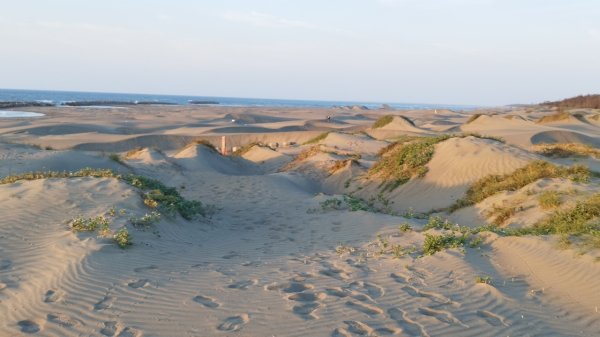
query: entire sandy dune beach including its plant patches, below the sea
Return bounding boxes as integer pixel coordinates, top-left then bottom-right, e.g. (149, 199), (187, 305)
(0, 105), (600, 337)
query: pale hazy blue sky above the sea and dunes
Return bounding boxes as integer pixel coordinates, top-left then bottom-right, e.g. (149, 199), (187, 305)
(0, 0), (600, 105)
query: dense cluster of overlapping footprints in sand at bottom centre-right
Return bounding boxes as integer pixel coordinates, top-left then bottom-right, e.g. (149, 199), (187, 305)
(278, 262), (509, 337)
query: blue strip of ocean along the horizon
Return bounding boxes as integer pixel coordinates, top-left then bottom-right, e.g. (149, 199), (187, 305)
(0, 89), (477, 110)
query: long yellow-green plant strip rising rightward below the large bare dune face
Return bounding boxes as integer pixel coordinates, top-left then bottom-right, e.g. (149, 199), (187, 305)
(448, 160), (591, 212)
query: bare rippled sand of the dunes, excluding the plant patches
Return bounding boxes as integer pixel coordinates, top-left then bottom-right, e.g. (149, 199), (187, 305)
(0, 103), (600, 336)
